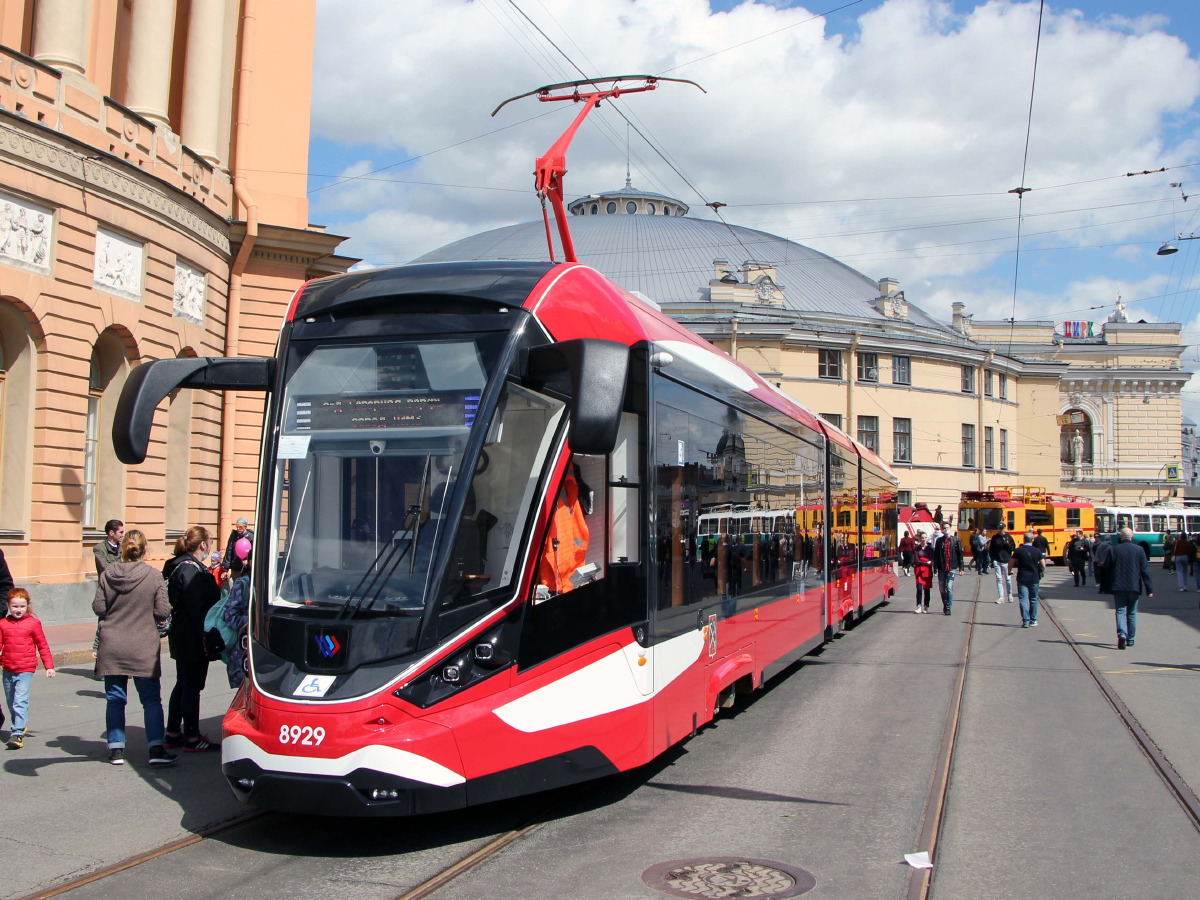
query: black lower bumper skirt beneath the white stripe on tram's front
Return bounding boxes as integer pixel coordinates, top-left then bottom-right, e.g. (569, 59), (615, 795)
(221, 746), (618, 816)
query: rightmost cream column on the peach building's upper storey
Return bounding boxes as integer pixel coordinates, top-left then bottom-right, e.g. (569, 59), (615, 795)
(181, 0), (226, 166)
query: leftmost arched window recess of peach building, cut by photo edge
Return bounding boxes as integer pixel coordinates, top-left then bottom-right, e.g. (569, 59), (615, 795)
(0, 301), (37, 535)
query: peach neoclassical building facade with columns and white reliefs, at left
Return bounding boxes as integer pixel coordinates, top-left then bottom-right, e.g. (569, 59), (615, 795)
(0, 0), (354, 614)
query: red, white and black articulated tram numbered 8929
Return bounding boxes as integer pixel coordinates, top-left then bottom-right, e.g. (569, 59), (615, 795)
(114, 77), (896, 816)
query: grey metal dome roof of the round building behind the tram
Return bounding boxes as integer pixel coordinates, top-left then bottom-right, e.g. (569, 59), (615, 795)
(413, 195), (958, 337)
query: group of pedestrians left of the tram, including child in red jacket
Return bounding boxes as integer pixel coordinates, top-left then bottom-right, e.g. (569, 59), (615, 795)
(0, 518), (253, 766)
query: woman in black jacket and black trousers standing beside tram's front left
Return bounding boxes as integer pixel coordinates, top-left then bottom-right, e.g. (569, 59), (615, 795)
(163, 526), (221, 754)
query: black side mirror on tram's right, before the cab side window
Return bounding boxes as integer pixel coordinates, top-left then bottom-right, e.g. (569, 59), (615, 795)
(524, 338), (629, 456)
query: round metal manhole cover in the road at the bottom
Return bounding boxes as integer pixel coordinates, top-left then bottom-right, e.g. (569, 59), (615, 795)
(642, 857), (817, 900)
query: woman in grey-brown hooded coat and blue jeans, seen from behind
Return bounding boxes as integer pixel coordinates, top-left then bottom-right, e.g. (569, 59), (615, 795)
(91, 530), (178, 766)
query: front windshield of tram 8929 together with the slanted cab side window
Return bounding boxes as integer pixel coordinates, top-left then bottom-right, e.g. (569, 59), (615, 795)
(266, 332), (563, 624)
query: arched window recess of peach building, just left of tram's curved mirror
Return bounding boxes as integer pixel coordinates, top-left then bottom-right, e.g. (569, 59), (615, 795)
(82, 329), (128, 530)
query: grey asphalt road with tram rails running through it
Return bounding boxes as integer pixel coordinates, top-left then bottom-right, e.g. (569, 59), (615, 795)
(0, 571), (1200, 900)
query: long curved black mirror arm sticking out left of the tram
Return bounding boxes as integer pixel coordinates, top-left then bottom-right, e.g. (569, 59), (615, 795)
(113, 356), (275, 466)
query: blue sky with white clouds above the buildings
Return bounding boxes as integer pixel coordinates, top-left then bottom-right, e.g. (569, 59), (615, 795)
(308, 0), (1200, 412)
